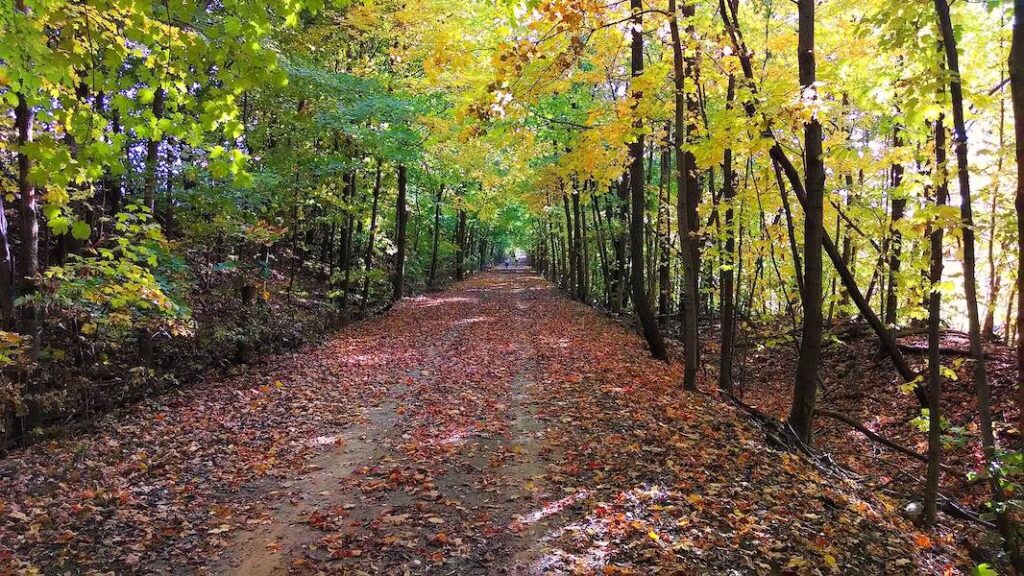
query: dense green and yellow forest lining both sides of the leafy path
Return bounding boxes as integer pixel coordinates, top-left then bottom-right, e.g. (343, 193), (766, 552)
(8, 0), (1024, 569)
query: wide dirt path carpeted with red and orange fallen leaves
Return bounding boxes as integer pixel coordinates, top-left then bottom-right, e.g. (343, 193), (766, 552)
(0, 271), (969, 576)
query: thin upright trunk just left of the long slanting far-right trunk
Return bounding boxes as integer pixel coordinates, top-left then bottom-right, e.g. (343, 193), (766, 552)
(925, 116), (949, 524)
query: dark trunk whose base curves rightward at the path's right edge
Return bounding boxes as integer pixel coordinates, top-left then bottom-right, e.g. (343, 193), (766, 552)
(630, 0), (669, 362)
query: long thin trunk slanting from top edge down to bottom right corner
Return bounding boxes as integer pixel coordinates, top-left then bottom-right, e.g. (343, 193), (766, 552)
(935, 0), (1024, 573)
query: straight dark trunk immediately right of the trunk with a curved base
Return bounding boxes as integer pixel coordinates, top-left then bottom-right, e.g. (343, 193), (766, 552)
(669, 0), (700, 381)
